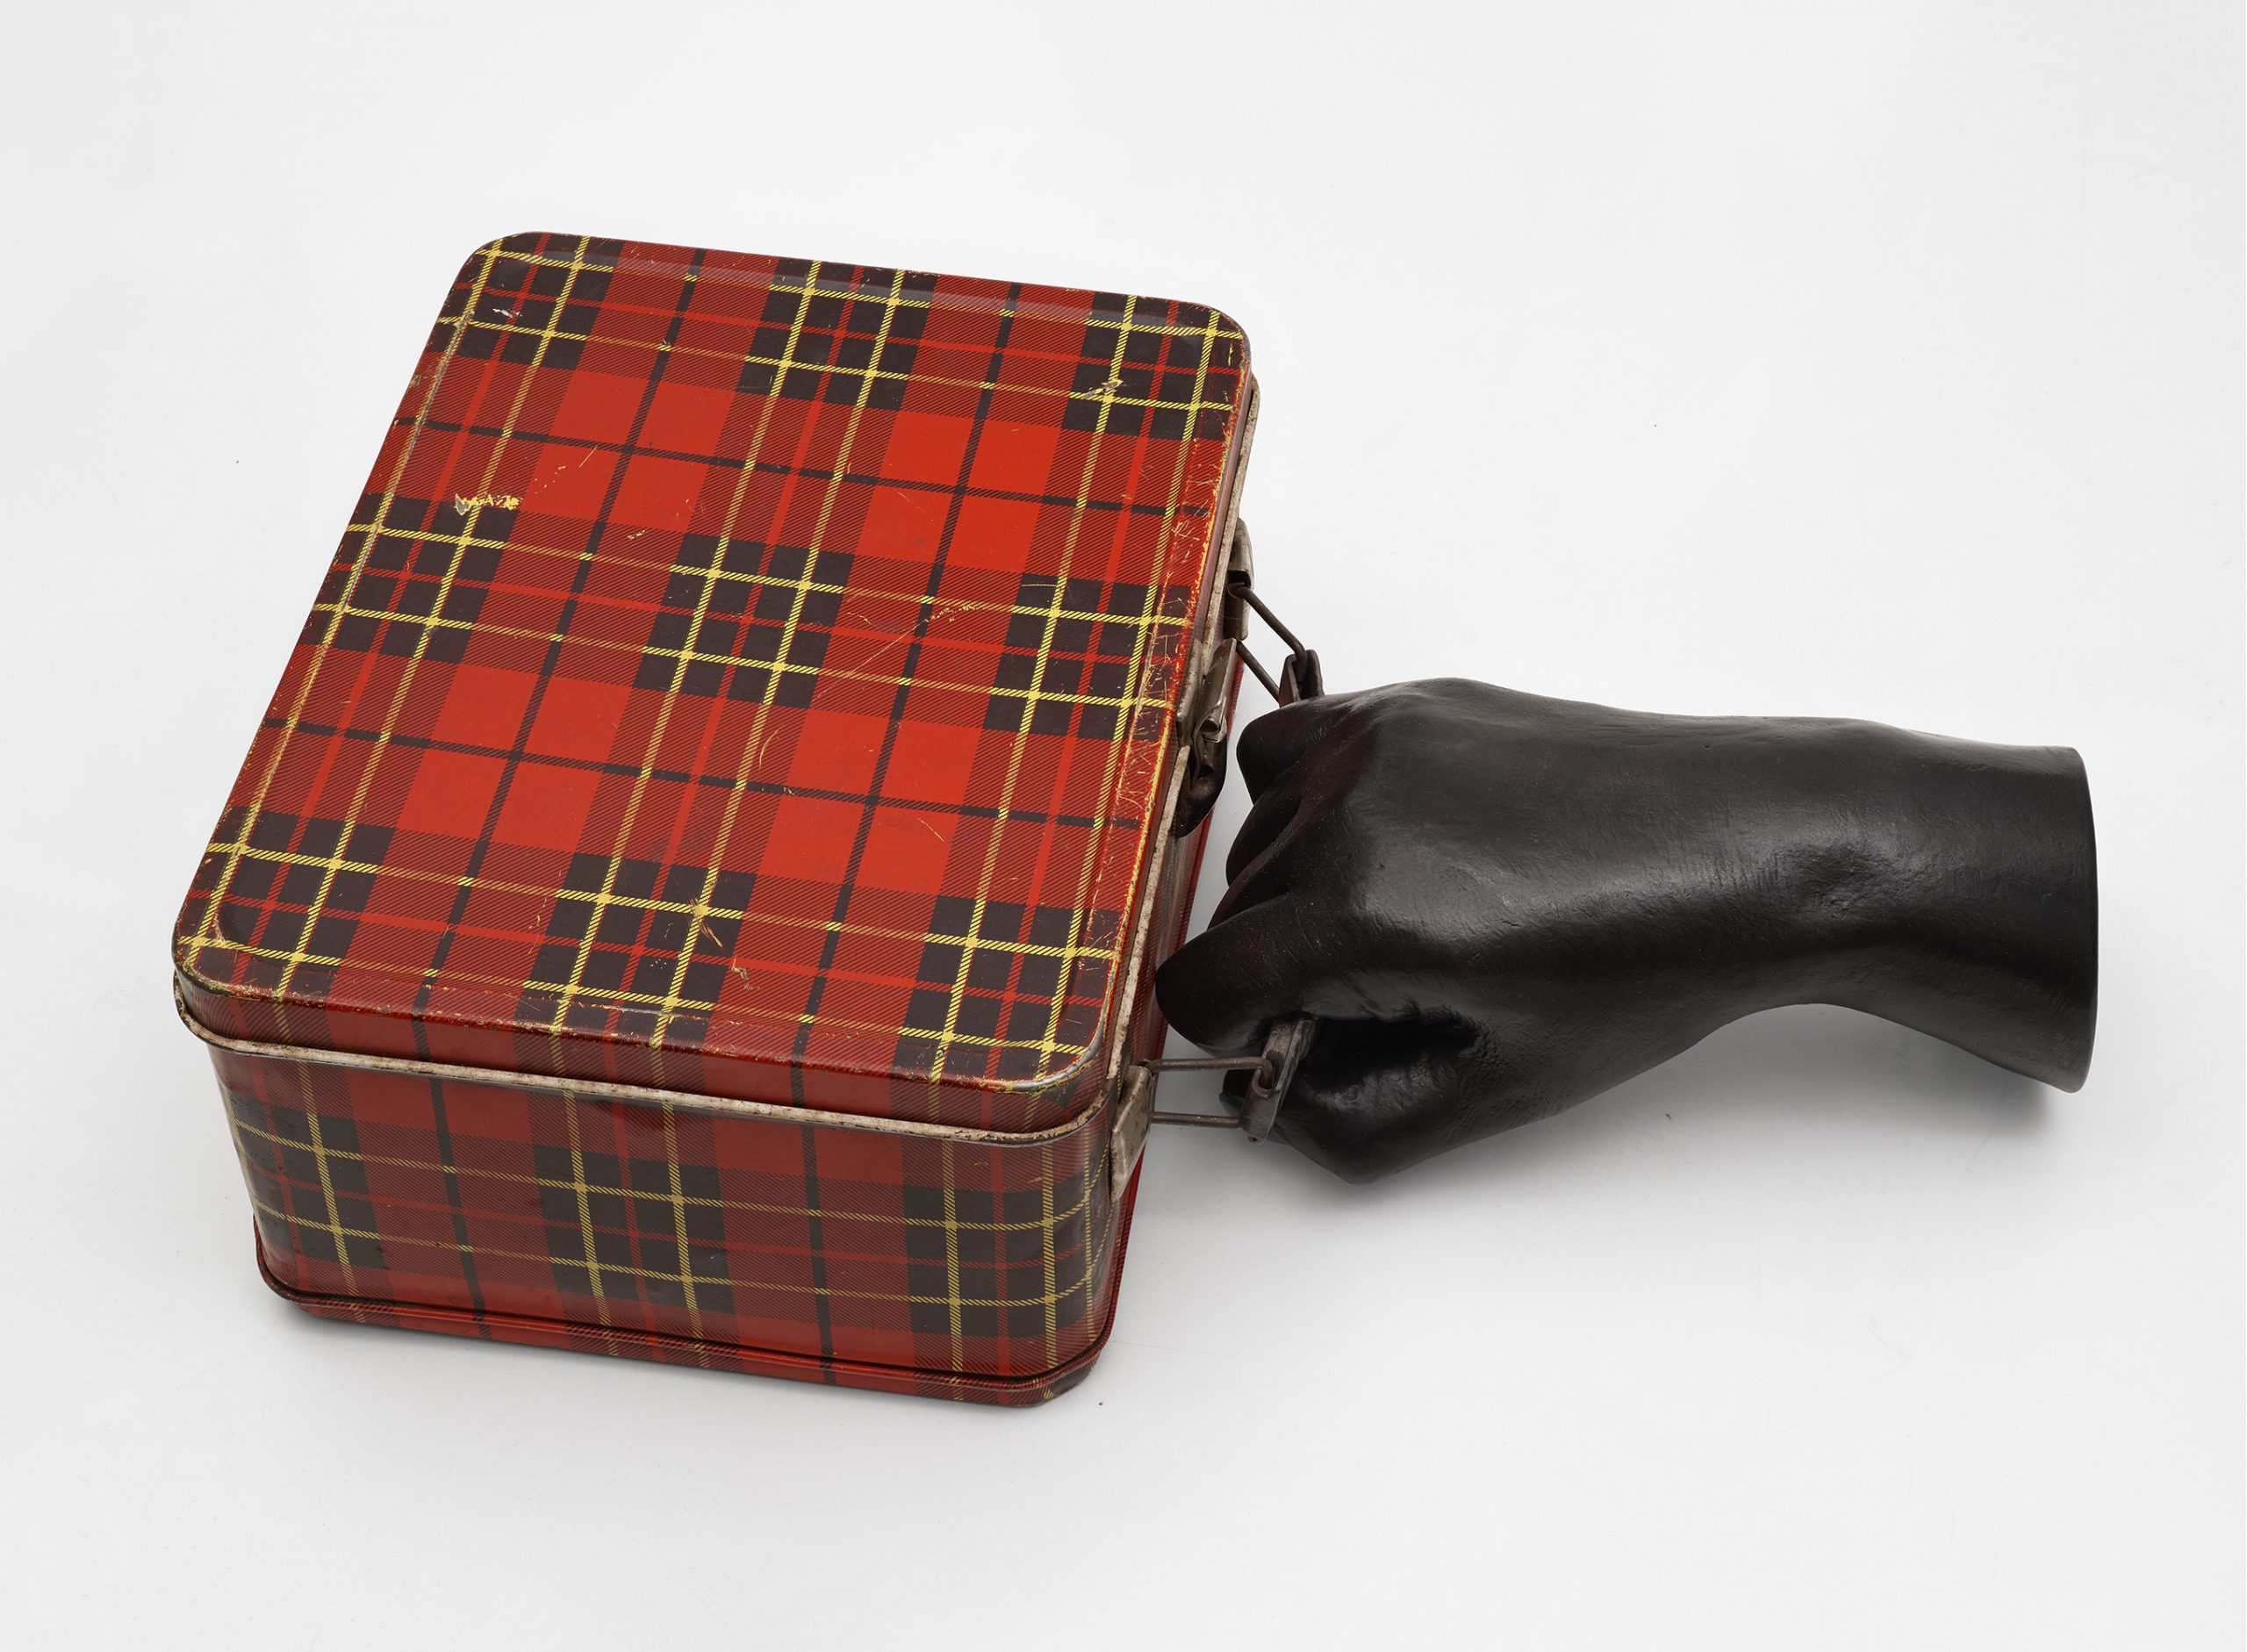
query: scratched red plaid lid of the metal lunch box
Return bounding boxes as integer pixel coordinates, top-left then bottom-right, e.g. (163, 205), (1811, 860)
(176, 236), (1249, 1137)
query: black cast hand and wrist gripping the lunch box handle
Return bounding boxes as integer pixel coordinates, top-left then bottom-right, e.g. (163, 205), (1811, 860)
(1157, 681), (2096, 1180)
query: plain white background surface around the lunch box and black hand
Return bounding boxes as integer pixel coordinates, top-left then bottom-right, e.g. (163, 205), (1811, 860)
(0, 0), (2243, 1652)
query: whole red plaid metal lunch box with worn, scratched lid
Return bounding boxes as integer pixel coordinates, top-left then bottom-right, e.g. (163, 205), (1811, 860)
(173, 236), (1315, 1404)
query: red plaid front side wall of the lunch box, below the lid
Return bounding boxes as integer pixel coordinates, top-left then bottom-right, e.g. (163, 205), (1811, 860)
(212, 1050), (1121, 1403)
